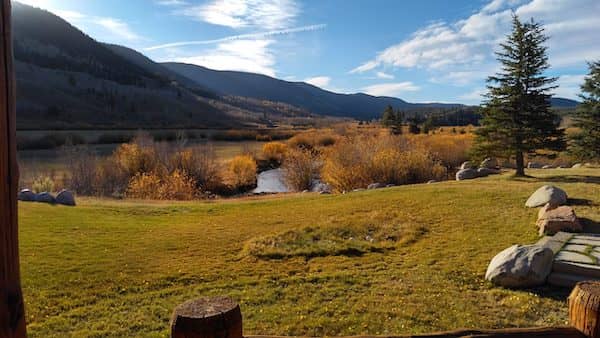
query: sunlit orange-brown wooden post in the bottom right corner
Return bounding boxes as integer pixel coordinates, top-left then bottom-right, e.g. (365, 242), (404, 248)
(569, 281), (600, 338)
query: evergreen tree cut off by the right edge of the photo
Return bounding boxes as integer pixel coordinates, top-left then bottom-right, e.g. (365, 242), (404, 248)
(569, 61), (600, 161)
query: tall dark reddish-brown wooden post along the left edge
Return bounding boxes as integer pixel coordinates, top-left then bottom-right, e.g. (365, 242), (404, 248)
(0, 0), (26, 338)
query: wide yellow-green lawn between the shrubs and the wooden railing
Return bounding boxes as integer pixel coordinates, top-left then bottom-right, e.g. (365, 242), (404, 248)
(19, 169), (600, 337)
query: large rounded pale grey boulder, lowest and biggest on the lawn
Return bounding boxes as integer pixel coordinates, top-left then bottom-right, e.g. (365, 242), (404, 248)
(485, 244), (554, 288)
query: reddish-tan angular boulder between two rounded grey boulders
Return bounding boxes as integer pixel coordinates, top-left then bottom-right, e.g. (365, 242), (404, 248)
(536, 203), (583, 235)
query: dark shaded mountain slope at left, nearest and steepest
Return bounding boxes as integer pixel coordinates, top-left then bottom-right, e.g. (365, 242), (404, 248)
(12, 2), (238, 129)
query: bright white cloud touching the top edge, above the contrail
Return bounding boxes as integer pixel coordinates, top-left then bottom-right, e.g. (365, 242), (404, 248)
(178, 0), (300, 30)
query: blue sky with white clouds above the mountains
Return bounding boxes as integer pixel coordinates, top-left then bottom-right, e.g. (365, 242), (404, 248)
(16, 0), (600, 104)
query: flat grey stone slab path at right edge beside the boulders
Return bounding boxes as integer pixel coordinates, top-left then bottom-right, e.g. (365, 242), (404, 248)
(538, 232), (600, 287)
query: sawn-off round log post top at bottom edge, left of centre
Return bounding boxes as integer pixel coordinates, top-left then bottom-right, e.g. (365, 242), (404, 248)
(171, 297), (243, 338)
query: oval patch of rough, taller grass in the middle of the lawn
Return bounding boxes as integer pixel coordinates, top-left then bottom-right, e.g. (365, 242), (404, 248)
(242, 224), (426, 259)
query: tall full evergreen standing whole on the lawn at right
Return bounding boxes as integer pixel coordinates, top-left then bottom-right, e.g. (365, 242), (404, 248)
(475, 16), (564, 176)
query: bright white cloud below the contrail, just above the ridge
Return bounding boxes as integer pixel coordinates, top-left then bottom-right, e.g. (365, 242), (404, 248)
(174, 40), (275, 76)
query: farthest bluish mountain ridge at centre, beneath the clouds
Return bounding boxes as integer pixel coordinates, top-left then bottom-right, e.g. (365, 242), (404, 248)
(163, 62), (461, 119)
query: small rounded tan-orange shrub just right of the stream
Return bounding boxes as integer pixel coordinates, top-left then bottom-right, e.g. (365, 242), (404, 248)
(282, 148), (319, 191)
